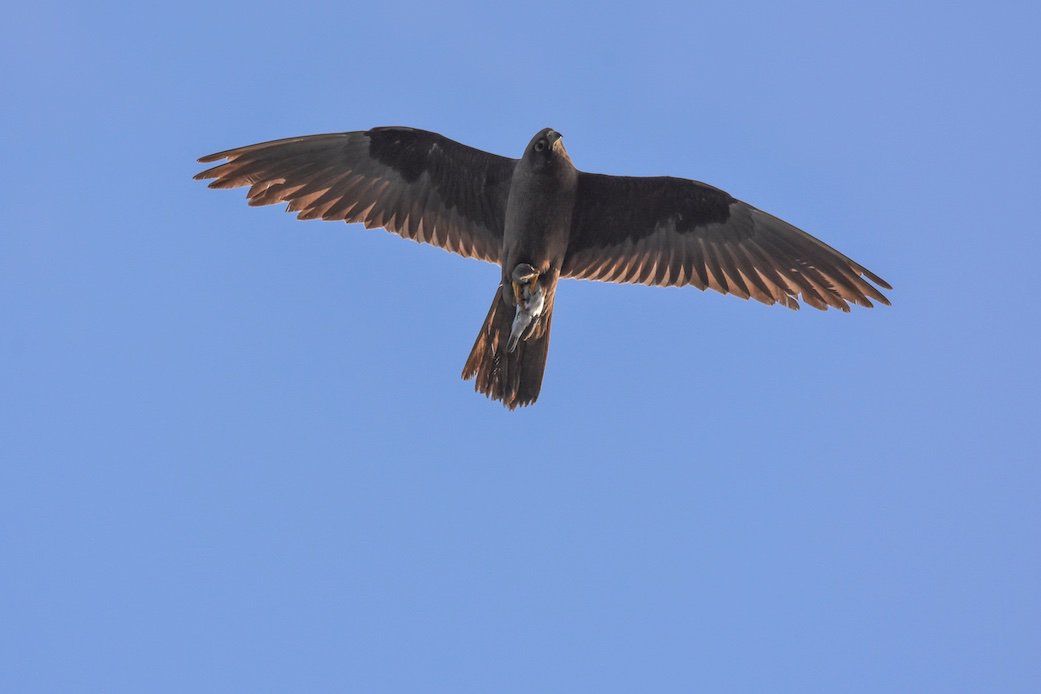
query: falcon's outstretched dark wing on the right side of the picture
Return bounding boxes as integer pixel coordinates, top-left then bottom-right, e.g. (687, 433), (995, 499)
(561, 173), (892, 311)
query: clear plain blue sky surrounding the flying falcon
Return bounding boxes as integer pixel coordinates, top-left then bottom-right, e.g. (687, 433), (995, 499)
(0, 0), (1041, 693)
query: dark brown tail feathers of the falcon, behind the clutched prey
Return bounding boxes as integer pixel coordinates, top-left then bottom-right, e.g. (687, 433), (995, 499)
(462, 287), (553, 410)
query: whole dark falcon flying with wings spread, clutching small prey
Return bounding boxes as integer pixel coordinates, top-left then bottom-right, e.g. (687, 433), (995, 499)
(195, 127), (891, 410)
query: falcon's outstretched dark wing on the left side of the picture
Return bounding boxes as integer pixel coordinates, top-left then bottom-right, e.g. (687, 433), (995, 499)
(195, 128), (516, 262)
